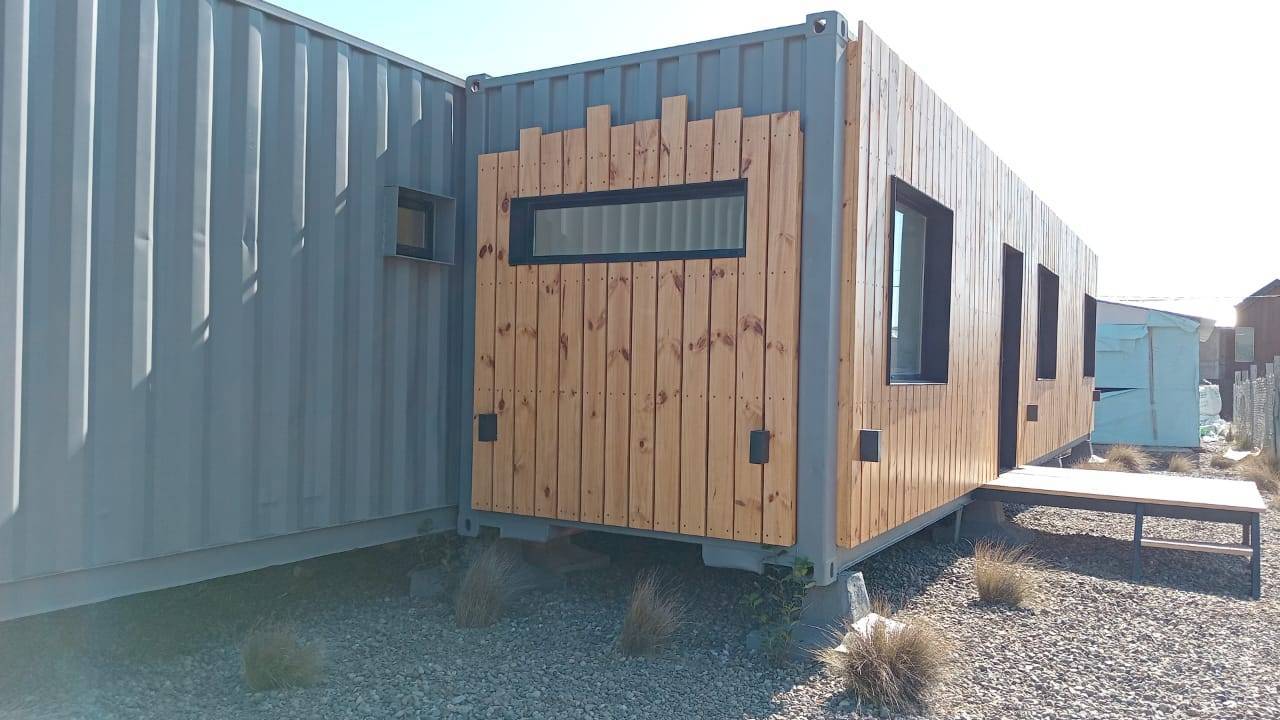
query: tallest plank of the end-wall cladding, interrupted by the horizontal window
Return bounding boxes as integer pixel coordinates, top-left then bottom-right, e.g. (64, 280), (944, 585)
(653, 95), (687, 533)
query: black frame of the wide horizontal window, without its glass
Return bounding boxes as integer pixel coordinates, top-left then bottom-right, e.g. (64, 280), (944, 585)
(507, 178), (750, 265)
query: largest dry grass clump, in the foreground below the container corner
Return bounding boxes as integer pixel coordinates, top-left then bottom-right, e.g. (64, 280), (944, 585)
(818, 605), (954, 714)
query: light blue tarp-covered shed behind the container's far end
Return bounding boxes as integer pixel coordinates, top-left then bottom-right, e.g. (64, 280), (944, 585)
(1092, 302), (1213, 447)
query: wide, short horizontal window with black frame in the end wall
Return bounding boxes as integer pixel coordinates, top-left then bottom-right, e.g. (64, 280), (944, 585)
(511, 179), (746, 265)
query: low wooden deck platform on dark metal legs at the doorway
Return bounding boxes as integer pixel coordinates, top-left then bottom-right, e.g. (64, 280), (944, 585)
(974, 466), (1267, 598)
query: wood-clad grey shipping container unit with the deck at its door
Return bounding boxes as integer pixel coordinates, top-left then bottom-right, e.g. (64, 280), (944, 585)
(461, 13), (1096, 584)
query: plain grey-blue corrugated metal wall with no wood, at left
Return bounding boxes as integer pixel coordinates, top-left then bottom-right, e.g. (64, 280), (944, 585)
(0, 0), (462, 582)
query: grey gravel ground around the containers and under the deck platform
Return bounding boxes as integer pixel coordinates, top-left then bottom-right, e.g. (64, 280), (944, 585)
(0, 458), (1280, 720)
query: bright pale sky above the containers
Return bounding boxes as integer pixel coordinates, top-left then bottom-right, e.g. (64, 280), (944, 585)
(275, 0), (1280, 322)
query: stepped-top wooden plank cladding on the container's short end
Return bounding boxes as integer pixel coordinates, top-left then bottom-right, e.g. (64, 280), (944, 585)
(471, 96), (803, 546)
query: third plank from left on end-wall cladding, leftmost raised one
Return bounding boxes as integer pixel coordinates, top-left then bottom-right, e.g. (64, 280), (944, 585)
(508, 128), (543, 515)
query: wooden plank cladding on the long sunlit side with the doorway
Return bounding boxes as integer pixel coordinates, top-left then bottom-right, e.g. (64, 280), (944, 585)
(839, 24), (1097, 548)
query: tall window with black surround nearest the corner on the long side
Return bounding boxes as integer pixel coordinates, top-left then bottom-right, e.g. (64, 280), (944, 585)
(888, 178), (952, 383)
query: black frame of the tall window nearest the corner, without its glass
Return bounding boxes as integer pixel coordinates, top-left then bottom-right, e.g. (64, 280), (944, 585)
(884, 176), (955, 386)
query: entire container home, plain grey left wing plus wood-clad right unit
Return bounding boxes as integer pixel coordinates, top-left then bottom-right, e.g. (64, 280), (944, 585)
(0, 0), (1096, 618)
